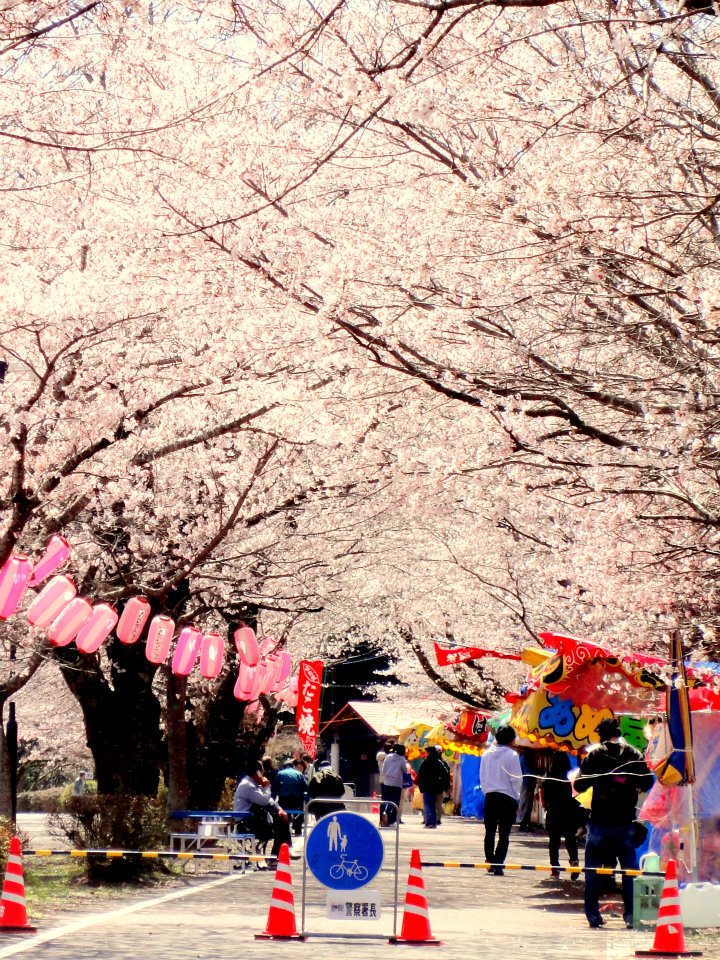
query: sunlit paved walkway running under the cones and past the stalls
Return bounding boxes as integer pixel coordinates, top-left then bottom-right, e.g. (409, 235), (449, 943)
(7, 817), (720, 960)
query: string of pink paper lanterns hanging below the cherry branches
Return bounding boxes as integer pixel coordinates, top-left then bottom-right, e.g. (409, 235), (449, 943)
(0, 535), (298, 707)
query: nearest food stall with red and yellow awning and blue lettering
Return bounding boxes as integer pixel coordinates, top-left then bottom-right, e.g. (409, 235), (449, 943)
(508, 633), (720, 882)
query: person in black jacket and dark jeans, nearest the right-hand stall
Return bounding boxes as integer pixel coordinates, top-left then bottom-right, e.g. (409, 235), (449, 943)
(575, 717), (653, 929)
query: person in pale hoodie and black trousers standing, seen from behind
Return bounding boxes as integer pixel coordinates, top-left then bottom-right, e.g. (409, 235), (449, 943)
(480, 725), (522, 877)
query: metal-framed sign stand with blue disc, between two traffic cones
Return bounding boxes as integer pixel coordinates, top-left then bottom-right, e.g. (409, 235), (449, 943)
(300, 797), (400, 942)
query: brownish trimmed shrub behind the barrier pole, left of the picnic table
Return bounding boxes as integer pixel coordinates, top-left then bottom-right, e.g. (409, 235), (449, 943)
(49, 794), (167, 883)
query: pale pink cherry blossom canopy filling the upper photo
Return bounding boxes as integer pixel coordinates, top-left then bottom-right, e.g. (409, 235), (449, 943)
(0, 0), (720, 816)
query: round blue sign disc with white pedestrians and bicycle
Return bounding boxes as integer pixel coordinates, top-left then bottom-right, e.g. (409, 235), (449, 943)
(305, 812), (385, 890)
